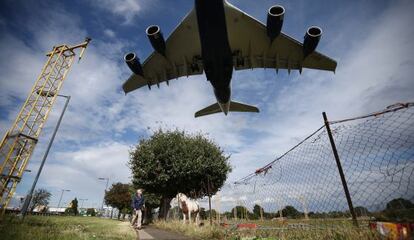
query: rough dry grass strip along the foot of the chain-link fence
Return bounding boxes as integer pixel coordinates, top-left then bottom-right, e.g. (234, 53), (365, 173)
(154, 221), (379, 240)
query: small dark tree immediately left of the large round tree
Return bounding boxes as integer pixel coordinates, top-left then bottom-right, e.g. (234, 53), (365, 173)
(105, 182), (132, 219)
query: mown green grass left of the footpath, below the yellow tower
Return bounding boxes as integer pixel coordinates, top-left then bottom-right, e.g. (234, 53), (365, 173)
(0, 216), (137, 240)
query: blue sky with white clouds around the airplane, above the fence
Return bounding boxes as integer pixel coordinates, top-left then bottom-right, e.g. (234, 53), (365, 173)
(0, 0), (414, 210)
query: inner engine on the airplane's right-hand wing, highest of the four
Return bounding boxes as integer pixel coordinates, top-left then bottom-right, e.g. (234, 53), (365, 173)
(266, 5), (285, 41)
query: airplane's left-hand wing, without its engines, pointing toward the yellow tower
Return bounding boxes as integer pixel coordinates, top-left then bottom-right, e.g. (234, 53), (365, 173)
(122, 9), (203, 93)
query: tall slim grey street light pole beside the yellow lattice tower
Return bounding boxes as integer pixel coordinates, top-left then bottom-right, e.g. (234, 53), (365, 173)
(21, 94), (70, 218)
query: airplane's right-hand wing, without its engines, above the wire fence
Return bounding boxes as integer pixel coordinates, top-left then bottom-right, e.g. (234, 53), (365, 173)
(225, 1), (336, 72)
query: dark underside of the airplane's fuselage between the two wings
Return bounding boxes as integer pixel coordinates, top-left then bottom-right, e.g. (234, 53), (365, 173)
(195, 0), (233, 114)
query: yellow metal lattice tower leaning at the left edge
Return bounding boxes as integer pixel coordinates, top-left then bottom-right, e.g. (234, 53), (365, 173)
(0, 38), (91, 214)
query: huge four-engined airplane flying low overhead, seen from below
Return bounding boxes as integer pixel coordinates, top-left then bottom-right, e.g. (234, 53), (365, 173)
(123, 0), (337, 117)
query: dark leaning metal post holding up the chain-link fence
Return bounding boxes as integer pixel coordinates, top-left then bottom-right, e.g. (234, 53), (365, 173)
(322, 112), (358, 227)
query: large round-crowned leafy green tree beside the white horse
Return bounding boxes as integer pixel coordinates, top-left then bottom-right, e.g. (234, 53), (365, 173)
(129, 129), (231, 219)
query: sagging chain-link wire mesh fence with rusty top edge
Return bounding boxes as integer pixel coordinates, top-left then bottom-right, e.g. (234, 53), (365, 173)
(193, 103), (414, 232)
